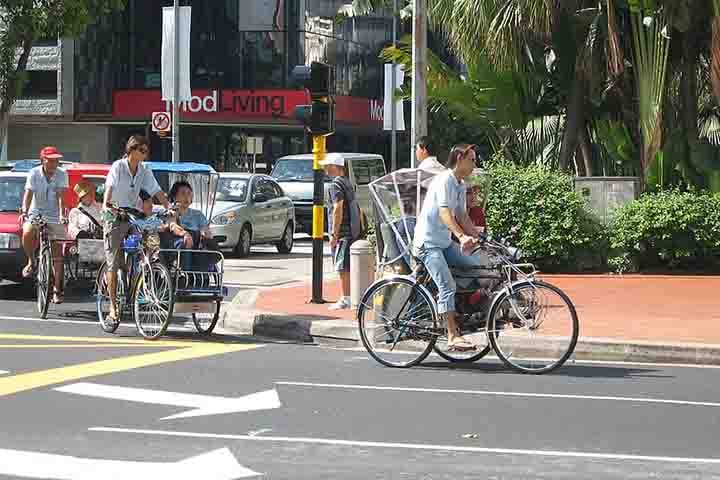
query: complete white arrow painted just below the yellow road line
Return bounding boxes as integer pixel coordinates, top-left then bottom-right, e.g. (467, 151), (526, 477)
(55, 382), (282, 420)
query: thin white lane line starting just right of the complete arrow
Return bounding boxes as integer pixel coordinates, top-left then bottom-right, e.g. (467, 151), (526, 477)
(275, 382), (720, 407)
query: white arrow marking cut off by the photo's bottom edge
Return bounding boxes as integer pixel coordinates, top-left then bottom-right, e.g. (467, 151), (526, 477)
(0, 448), (262, 480)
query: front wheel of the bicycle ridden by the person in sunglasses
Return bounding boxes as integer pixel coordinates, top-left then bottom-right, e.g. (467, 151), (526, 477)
(132, 263), (173, 340)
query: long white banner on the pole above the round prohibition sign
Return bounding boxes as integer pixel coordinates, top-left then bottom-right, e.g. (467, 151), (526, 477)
(161, 7), (192, 102)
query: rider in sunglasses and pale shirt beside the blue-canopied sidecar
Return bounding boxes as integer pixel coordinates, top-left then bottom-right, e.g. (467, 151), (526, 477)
(103, 135), (170, 322)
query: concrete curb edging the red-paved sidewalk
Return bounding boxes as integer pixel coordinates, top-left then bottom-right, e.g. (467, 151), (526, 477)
(224, 311), (720, 365)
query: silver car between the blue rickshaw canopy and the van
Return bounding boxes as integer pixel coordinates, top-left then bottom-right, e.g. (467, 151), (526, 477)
(210, 172), (295, 258)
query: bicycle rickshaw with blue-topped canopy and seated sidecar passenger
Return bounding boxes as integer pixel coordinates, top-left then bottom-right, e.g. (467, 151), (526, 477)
(96, 162), (227, 340)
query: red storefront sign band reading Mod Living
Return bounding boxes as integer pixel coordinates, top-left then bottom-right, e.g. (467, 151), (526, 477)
(113, 90), (383, 128)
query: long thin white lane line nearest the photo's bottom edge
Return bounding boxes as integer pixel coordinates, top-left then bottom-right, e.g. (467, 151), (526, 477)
(88, 427), (720, 464)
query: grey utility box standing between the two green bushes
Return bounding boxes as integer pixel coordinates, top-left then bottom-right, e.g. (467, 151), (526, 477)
(575, 177), (640, 224)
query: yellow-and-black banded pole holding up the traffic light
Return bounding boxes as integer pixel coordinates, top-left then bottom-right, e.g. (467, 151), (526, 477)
(310, 135), (326, 303)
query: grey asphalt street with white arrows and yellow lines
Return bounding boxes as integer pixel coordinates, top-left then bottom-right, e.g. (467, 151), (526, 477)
(0, 245), (720, 479)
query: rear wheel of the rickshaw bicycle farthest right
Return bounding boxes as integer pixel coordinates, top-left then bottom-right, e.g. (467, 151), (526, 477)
(357, 277), (437, 368)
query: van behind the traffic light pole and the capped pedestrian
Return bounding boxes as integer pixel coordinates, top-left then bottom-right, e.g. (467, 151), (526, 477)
(270, 153), (386, 235)
